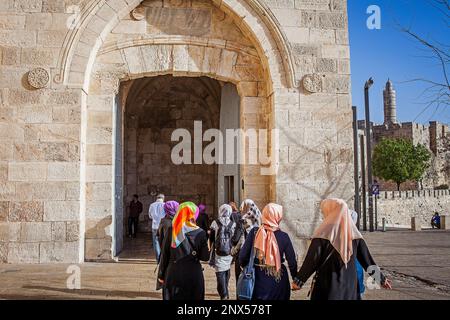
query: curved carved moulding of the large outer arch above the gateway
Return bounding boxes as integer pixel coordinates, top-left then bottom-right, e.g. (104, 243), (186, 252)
(54, 0), (297, 94)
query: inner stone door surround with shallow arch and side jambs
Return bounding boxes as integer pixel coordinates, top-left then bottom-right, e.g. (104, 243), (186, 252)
(77, 3), (284, 260)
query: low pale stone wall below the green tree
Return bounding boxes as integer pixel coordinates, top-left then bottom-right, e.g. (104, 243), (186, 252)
(377, 190), (450, 228)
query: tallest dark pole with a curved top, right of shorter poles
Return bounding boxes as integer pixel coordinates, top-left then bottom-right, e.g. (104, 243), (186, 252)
(364, 78), (374, 232)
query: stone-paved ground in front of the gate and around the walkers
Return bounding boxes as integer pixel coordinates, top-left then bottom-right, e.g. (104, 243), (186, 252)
(0, 231), (450, 300)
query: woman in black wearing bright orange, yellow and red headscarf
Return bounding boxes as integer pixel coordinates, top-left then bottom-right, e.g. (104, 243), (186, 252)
(158, 202), (209, 300)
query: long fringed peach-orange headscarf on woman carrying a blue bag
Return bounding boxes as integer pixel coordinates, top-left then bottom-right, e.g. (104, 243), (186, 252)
(255, 203), (283, 279)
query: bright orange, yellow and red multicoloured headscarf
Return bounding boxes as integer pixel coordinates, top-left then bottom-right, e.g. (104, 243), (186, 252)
(172, 202), (199, 248)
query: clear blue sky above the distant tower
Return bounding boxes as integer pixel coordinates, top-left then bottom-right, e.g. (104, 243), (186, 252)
(348, 0), (450, 123)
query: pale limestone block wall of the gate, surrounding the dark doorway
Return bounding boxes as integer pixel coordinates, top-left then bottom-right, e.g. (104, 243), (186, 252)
(0, 0), (353, 263)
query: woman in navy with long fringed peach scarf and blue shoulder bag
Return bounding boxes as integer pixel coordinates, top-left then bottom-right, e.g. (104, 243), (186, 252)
(239, 203), (297, 300)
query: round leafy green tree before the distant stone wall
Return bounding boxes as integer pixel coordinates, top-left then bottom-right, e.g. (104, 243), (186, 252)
(372, 139), (431, 190)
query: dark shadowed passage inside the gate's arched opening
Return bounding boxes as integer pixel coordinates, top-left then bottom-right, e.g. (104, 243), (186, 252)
(113, 75), (241, 260)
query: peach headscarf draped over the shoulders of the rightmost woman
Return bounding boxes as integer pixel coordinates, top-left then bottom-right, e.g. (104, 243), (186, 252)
(313, 199), (362, 265)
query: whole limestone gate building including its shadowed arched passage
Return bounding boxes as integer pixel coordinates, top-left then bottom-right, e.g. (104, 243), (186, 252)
(0, 0), (353, 263)
